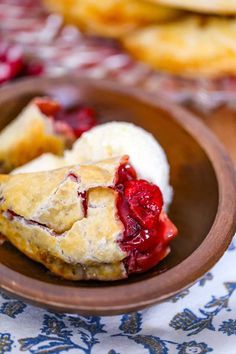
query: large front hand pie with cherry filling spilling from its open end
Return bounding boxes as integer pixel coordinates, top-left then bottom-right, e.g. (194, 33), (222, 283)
(0, 156), (177, 280)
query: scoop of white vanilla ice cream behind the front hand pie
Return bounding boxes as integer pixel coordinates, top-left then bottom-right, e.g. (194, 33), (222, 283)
(65, 122), (172, 207)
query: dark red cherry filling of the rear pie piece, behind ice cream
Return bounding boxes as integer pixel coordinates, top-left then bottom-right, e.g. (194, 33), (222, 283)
(35, 98), (96, 140)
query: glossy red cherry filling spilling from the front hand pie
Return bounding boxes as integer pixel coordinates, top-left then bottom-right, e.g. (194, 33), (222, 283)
(115, 163), (177, 274)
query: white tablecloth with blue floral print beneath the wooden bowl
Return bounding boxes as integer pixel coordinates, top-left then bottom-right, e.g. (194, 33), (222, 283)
(0, 235), (236, 354)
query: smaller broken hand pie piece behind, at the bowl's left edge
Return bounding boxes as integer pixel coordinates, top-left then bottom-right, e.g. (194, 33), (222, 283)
(0, 98), (74, 172)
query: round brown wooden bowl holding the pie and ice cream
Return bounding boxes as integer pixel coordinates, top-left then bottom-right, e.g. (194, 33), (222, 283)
(0, 77), (236, 315)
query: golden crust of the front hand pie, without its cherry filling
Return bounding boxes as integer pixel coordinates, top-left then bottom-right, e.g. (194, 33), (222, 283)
(0, 157), (127, 280)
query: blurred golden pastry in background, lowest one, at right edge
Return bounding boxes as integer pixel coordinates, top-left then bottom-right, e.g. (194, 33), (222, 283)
(123, 15), (236, 78)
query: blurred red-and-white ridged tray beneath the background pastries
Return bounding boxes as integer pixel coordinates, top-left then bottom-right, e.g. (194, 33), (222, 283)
(0, 0), (236, 162)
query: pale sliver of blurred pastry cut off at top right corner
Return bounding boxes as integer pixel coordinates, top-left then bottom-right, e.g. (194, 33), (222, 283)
(151, 0), (236, 15)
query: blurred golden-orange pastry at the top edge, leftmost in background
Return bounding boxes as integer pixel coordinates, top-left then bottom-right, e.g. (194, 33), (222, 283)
(44, 0), (181, 37)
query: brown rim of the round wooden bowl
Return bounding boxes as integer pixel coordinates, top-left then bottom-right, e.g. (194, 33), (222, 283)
(0, 76), (236, 315)
